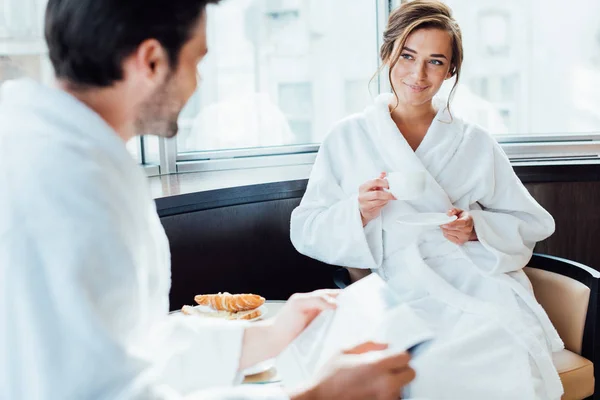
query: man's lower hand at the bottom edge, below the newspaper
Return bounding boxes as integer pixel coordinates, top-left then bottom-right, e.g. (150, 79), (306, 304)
(290, 343), (415, 400)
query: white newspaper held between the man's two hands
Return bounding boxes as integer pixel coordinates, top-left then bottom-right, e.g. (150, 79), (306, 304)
(277, 274), (434, 387)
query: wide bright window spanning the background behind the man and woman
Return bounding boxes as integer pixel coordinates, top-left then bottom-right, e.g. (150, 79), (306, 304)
(0, 0), (600, 173)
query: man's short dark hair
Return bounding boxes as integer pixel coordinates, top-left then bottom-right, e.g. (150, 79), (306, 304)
(45, 0), (220, 87)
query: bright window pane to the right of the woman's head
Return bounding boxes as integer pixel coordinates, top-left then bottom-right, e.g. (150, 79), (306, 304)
(444, 0), (600, 135)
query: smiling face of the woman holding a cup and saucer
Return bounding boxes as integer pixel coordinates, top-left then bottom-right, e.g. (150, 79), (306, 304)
(391, 28), (452, 106)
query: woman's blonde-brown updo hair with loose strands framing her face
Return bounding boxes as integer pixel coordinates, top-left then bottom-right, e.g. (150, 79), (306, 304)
(375, 0), (463, 112)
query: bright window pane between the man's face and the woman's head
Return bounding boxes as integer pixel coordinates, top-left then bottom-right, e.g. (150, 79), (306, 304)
(178, 0), (378, 152)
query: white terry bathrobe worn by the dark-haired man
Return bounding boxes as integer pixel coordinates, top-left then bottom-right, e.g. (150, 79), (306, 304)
(0, 81), (287, 400)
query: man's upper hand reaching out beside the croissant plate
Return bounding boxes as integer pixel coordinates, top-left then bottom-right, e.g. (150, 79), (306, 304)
(239, 290), (340, 369)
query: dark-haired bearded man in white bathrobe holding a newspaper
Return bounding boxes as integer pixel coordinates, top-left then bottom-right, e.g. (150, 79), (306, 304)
(0, 0), (414, 400)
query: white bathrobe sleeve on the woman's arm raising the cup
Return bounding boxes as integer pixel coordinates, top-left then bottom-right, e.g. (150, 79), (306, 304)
(290, 127), (383, 269)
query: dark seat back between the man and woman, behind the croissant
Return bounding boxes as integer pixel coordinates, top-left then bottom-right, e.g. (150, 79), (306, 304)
(162, 198), (333, 309)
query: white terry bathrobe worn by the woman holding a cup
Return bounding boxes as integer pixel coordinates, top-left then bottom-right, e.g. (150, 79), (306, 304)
(291, 94), (563, 400)
